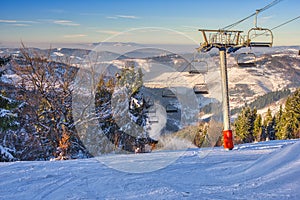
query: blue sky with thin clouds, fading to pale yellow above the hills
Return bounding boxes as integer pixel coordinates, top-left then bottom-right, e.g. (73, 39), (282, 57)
(0, 0), (300, 46)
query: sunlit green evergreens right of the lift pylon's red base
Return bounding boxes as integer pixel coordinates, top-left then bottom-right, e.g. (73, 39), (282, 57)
(234, 88), (300, 143)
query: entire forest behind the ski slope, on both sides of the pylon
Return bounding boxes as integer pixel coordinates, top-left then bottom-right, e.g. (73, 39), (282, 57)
(0, 47), (300, 161)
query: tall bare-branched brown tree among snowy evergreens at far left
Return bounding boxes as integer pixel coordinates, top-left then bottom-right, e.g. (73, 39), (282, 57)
(14, 45), (83, 159)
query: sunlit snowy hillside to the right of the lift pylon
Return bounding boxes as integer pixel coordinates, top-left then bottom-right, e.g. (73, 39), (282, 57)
(228, 47), (300, 109)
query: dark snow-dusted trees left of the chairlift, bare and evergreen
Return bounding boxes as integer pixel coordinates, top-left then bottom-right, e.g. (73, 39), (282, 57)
(0, 46), (157, 161)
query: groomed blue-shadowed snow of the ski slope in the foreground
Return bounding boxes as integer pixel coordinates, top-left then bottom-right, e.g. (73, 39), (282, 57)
(0, 140), (300, 200)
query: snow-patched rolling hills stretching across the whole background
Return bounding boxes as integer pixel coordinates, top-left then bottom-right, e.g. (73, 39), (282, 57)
(0, 46), (300, 130)
